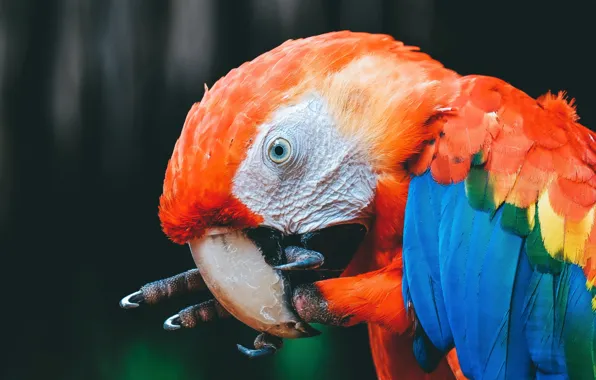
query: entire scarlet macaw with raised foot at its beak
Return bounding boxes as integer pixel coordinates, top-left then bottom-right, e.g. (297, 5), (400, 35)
(120, 31), (596, 380)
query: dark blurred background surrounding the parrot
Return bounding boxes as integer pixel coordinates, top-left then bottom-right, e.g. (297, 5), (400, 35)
(0, 0), (596, 380)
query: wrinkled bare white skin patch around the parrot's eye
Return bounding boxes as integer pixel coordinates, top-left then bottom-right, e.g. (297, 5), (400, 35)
(233, 94), (376, 234)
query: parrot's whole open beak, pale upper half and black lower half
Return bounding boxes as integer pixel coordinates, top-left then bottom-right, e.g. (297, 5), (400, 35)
(189, 224), (366, 338)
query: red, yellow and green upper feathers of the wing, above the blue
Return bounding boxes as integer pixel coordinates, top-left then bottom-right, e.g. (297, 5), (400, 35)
(411, 76), (596, 292)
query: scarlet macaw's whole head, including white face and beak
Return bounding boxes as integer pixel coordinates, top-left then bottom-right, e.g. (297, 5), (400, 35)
(159, 32), (453, 337)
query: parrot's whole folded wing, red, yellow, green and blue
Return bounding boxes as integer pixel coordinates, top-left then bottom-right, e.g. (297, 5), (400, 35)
(404, 76), (596, 379)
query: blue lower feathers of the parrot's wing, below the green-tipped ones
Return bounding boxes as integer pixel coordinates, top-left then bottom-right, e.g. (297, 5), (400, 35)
(403, 172), (596, 379)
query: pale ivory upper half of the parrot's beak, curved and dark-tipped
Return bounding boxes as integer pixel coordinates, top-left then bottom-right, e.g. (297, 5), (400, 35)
(190, 231), (318, 338)
